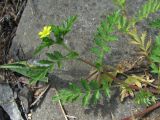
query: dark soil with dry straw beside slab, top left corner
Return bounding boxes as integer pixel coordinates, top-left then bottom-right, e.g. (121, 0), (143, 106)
(0, 0), (27, 64)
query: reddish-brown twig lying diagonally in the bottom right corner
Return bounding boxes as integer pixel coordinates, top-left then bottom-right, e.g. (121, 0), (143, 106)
(121, 102), (160, 120)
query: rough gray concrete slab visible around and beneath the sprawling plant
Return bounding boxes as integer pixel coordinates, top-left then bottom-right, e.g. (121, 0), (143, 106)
(11, 0), (160, 120)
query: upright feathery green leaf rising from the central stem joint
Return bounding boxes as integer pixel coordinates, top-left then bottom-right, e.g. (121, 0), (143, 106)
(91, 10), (120, 65)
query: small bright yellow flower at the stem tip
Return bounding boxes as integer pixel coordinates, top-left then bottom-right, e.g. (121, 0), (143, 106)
(38, 26), (51, 38)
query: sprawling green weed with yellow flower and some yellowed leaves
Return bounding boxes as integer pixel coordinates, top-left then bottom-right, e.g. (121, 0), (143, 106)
(0, 0), (160, 118)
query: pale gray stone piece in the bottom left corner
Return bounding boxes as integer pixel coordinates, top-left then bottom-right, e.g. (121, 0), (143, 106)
(0, 84), (23, 120)
